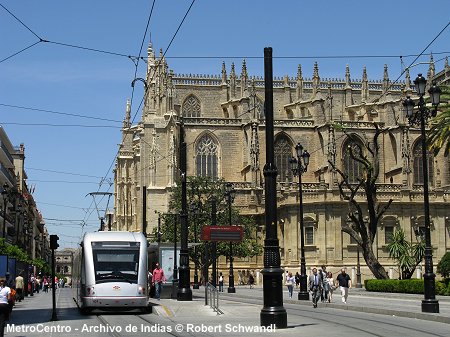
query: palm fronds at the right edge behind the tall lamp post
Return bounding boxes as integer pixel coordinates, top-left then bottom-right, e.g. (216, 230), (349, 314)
(427, 85), (450, 156)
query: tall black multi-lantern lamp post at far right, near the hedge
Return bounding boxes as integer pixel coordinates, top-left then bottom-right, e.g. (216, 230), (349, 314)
(403, 74), (441, 313)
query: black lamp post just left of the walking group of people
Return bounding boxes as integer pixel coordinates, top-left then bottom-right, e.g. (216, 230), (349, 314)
(289, 143), (310, 301)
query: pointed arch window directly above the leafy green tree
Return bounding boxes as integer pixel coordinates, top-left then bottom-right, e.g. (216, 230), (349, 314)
(195, 135), (218, 179)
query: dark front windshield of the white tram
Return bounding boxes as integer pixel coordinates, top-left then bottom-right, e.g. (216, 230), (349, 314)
(92, 247), (139, 283)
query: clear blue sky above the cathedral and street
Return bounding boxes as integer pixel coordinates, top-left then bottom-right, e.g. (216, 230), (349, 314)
(0, 0), (450, 247)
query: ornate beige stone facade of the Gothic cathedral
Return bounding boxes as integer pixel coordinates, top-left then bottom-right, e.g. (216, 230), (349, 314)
(113, 45), (450, 278)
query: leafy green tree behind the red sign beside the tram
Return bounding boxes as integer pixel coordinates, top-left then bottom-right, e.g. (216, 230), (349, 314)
(153, 177), (262, 277)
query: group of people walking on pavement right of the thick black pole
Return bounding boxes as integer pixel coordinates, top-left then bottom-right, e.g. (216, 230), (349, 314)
(285, 266), (352, 308)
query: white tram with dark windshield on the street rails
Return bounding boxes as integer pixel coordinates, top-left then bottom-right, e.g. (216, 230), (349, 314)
(72, 232), (148, 313)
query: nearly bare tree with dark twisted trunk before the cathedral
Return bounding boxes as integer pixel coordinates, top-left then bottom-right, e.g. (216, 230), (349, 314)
(328, 123), (392, 279)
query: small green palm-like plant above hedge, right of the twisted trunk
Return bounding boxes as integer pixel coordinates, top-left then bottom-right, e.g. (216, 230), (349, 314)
(387, 228), (425, 279)
